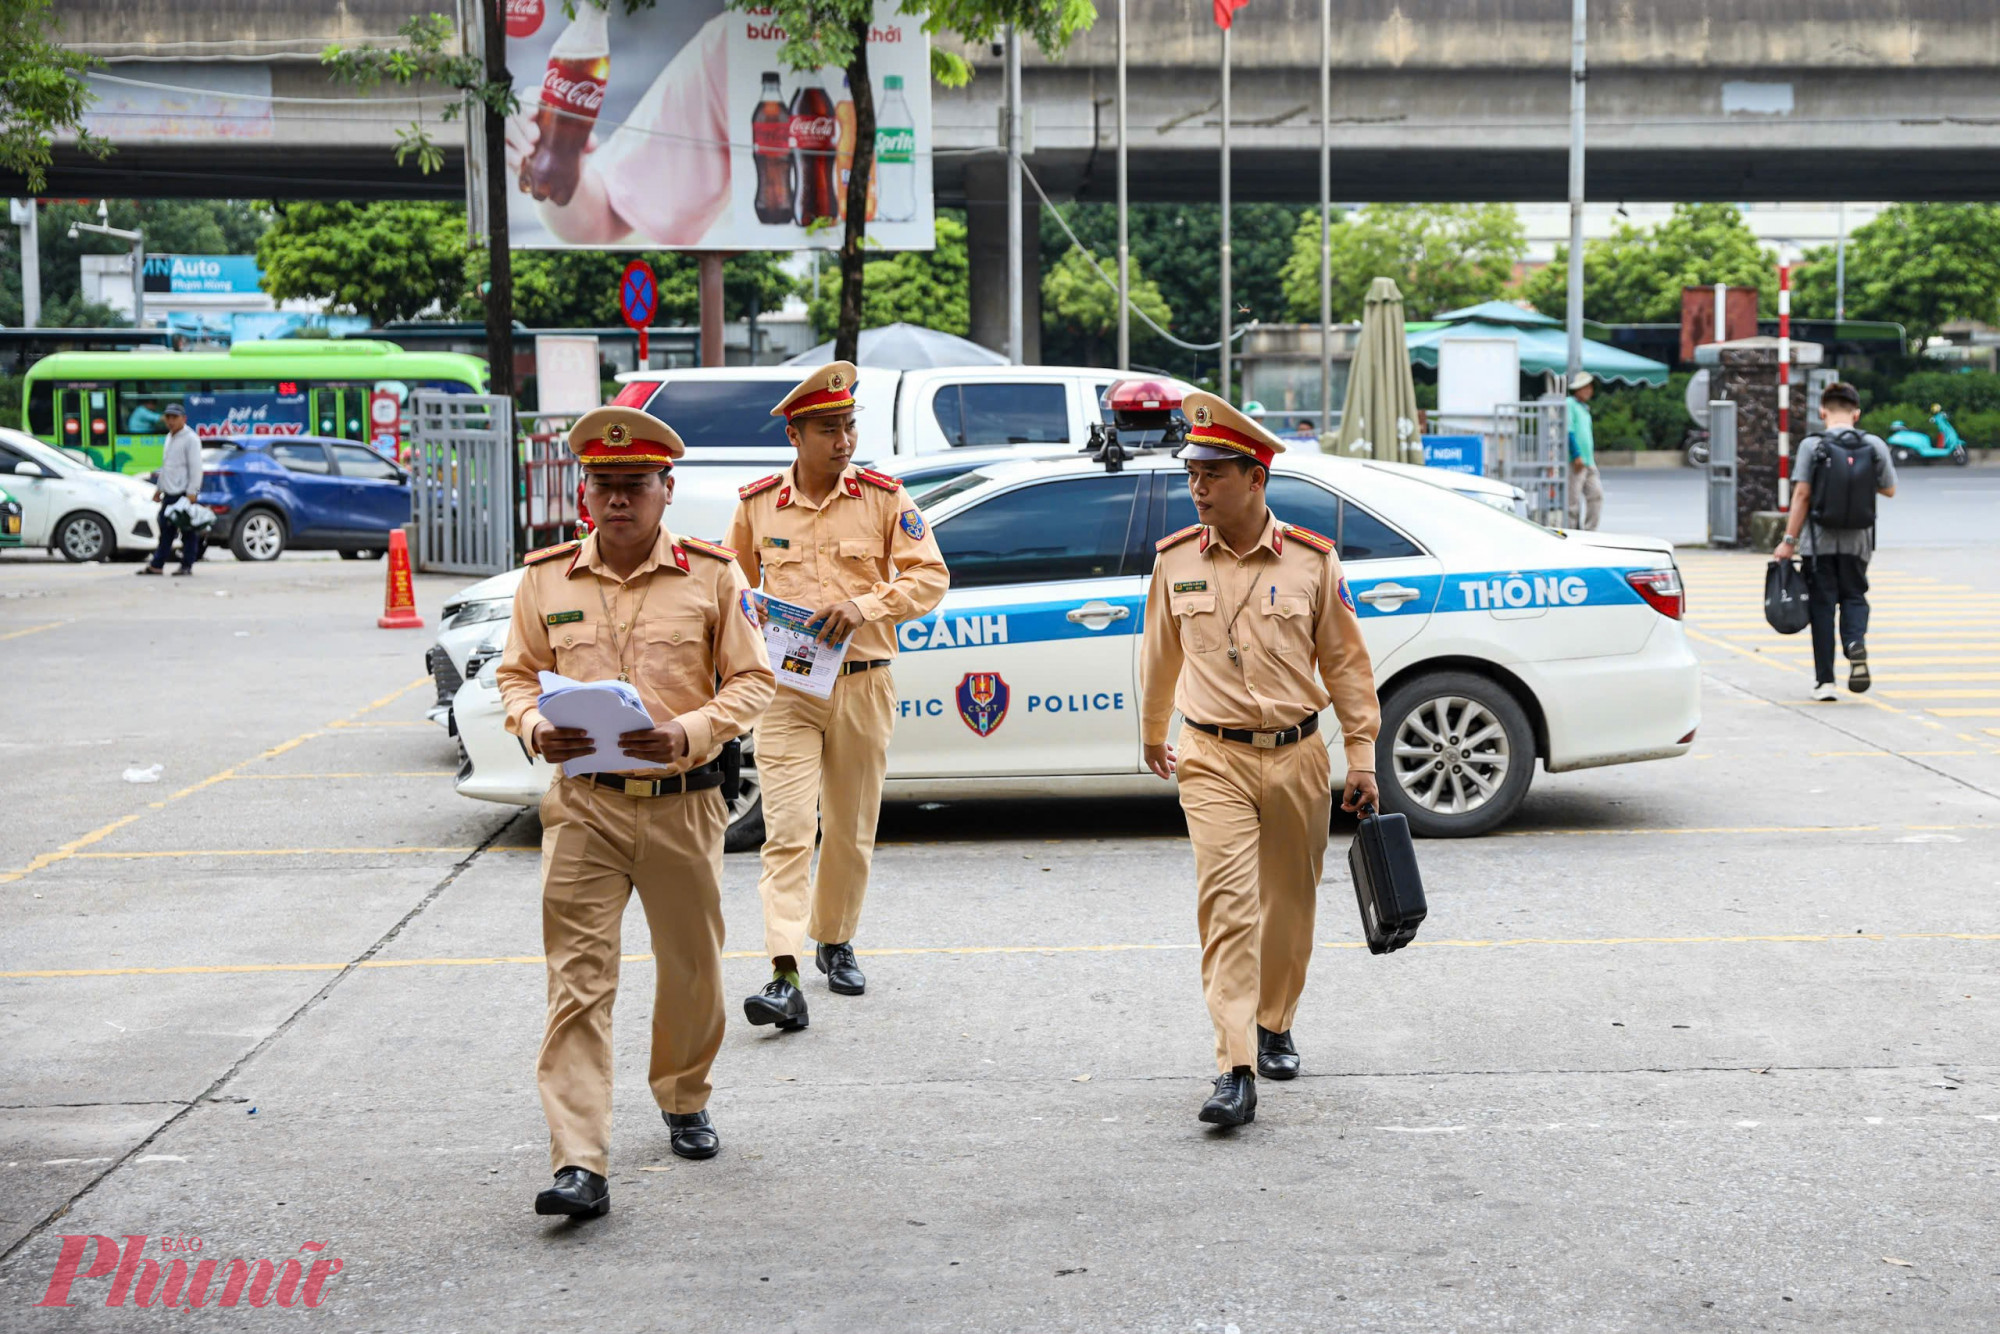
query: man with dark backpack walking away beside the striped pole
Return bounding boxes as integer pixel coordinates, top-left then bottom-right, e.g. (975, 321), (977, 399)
(1772, 380), (1896, 700)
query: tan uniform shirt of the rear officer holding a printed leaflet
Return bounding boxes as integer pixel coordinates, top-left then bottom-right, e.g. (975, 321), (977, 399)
(730, 464), (952, 662)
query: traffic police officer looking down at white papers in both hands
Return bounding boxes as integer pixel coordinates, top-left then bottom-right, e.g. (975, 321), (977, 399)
(500, 406), (774, 1218)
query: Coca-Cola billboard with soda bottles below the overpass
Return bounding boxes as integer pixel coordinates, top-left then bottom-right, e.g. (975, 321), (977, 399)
(504, 0), (934, 250)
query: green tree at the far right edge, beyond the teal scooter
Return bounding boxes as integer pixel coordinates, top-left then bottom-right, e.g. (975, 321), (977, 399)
(1792, 204), (2000, 352)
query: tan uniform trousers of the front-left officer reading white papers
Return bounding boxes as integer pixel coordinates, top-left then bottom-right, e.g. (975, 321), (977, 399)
(534, 778), (728, 1176)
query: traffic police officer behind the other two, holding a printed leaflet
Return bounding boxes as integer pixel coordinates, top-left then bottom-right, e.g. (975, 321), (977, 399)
(728, 362), (950, 1032)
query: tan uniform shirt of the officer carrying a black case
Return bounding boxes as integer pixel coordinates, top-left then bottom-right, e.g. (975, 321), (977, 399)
(1140, 518), (1382, 770)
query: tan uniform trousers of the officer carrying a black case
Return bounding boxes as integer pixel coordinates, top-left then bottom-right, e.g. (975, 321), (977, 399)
(1178, 728), (1334, 1070)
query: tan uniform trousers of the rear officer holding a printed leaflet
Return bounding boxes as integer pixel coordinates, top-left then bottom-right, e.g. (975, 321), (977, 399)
(756, 668), (896, 958)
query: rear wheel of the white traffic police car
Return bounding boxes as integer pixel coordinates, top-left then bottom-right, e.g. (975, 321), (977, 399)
(1376, 672), (1534, 838)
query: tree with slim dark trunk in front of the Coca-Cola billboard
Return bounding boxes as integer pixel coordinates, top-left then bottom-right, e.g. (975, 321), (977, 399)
(732, 0), (1098, 360)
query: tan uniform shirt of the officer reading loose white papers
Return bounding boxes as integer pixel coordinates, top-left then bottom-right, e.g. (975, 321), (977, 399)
(498, 524), (778, 774)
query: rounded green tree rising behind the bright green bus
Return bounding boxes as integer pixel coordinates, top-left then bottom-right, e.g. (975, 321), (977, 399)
(256, 200), (466, 324)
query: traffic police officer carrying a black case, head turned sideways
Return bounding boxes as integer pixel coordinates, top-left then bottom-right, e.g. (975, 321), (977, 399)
(1140, 392), (1382, 1126)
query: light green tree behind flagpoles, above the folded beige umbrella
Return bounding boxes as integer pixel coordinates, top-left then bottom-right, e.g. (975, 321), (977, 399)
(1280, 204), (1528, 324)
